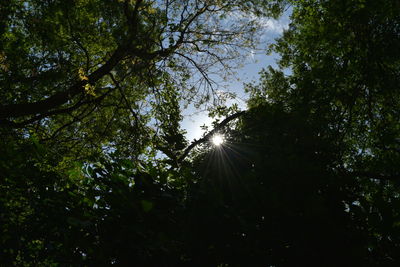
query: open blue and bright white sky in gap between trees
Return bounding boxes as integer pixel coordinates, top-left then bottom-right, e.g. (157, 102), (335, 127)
(181, 10), (290, 141)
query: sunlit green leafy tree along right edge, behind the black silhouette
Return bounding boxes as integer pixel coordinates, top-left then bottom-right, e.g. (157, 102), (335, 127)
(238, 1), (400, 266)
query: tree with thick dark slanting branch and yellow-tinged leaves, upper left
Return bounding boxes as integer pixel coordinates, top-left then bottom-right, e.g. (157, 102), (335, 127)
(0, 0), (283, 164)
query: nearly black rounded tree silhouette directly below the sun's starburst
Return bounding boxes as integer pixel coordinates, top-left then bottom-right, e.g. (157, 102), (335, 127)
(187, 103), (367, 266)
